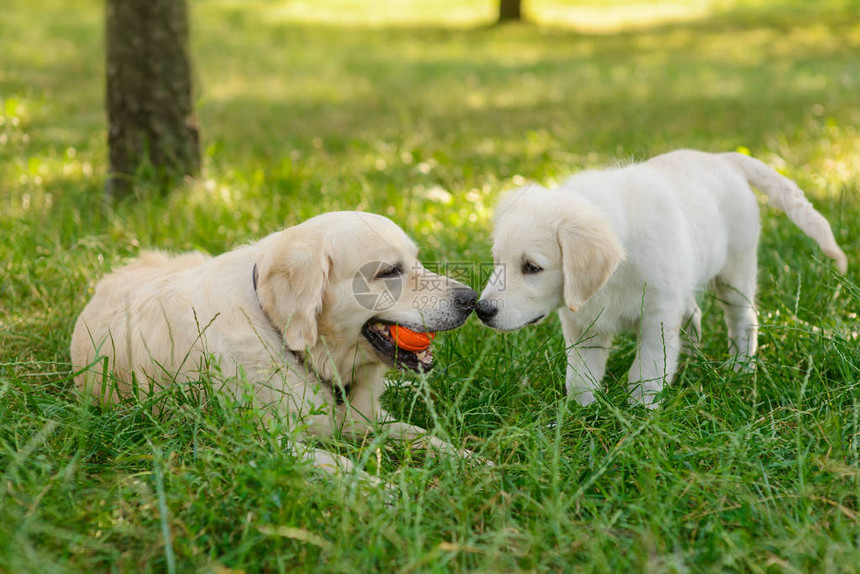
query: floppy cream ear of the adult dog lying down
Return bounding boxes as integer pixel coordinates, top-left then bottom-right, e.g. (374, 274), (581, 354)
(257, 229), (331, 351)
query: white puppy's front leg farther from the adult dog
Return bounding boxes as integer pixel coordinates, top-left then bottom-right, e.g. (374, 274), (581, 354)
(627, 317), (681, 409)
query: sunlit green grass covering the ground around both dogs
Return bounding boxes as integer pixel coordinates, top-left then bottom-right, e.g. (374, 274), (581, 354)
(0, 0), (860, 572)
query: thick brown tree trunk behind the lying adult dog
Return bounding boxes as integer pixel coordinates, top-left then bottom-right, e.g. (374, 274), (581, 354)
(105, 0), (200, 198)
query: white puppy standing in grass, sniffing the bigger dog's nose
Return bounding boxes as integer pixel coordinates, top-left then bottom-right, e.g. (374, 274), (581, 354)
(476, 150), (847, 407)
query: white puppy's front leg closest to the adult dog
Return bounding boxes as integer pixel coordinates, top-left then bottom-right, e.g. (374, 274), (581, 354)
(559, 309), (612, 406)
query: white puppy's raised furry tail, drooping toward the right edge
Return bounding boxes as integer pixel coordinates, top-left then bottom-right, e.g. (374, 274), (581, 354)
(720, 153), (848, 274)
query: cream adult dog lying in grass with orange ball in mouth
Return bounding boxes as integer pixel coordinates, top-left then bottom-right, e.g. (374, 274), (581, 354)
(71, 212), (477, 474)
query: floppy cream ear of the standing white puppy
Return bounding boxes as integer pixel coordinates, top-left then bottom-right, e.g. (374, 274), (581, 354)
(557, 210), (624, 312)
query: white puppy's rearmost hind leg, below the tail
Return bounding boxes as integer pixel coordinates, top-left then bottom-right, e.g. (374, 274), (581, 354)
(716, 251), (758, 371)
